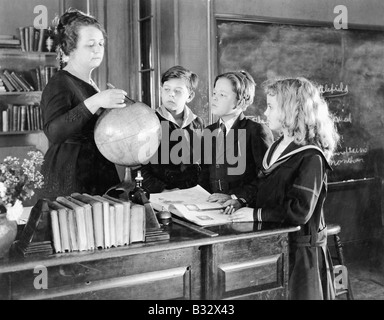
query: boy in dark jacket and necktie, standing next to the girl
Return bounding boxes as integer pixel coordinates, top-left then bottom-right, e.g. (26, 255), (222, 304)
(199, 71), (273, 208)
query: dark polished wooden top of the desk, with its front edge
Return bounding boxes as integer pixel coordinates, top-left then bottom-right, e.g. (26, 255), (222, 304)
(0, 222), (300, 273)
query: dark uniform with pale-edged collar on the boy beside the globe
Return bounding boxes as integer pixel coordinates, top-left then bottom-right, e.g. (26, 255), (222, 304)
(133, 106), (204, 193)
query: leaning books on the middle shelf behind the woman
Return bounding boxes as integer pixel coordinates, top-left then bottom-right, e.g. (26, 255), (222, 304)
(0, 65), (57, 93)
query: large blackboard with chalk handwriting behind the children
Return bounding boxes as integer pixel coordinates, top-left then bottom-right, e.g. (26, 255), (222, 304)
(215, 18), (384, 181)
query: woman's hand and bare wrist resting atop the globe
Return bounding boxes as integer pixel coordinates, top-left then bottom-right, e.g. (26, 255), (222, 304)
(84, 89), (127, 114)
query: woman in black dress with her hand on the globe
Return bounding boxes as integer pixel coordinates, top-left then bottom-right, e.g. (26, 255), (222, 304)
(39, 9), (126, 199)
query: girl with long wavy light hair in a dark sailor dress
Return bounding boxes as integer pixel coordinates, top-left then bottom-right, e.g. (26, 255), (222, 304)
(226, 78), (339, 300)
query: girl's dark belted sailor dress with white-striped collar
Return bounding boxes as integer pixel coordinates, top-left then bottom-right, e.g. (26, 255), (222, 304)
(251, 138), (335, 300)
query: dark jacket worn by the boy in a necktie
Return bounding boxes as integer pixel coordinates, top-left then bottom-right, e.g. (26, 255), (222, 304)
(199, 113), (273, 202)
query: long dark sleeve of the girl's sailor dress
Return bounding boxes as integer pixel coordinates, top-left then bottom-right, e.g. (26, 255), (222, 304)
(254, 154), (324, 225)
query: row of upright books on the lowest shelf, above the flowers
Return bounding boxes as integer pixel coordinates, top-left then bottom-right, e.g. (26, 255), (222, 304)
(0, 104), (43, 132)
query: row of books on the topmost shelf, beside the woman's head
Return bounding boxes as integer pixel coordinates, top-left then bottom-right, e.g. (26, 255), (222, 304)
(0, 26), (54, 52)
